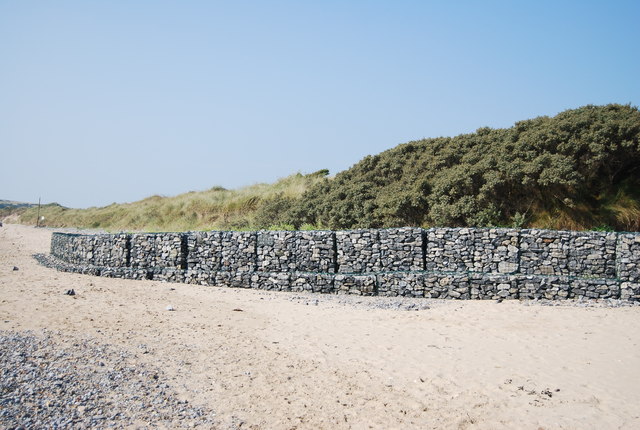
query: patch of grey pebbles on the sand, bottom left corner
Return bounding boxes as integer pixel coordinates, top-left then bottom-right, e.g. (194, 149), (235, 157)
(0, 330), (215, 429)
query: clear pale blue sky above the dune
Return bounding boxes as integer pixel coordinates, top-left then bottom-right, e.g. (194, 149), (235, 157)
(0, 0), (640, 207)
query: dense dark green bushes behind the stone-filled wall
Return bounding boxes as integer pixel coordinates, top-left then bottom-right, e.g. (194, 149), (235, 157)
(286, 105), (640, 230)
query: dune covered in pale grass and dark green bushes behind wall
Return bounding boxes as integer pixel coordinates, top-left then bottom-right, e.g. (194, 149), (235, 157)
(15, 104), (640, 231)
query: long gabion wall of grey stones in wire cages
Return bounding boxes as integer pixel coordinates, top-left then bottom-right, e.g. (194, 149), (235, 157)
(39, 227), (640, 301)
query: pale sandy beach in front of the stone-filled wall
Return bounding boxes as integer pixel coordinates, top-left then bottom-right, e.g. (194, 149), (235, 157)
(0, 224), (640, 429)
